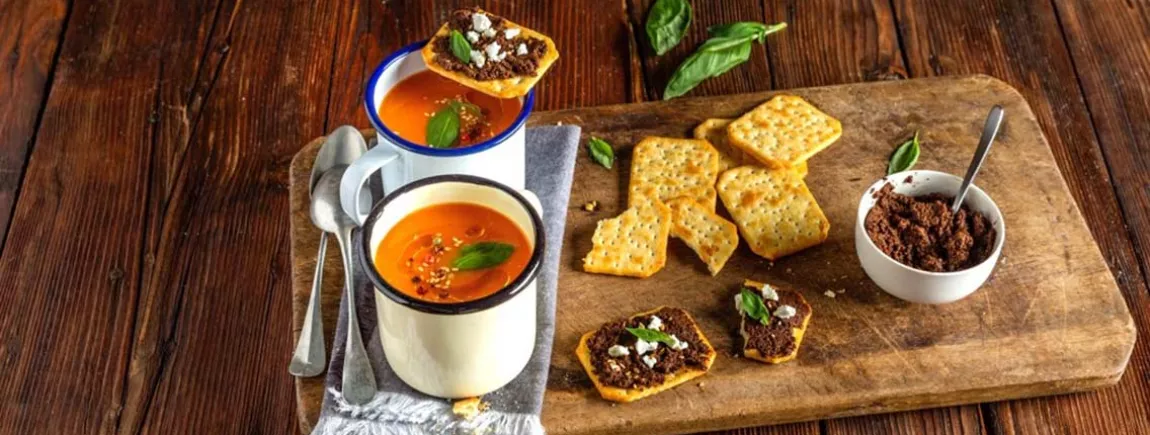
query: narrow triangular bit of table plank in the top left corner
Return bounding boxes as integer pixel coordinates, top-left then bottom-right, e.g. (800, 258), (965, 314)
(0, 0), (68, 245)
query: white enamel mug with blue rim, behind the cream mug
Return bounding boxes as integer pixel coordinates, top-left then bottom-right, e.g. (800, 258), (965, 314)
(339, 41), (535, 224)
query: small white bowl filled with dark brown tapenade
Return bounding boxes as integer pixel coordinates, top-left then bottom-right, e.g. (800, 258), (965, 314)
(854, 170), (1006, 304)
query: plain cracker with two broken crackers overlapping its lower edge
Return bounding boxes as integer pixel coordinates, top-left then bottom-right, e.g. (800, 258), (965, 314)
(627, 137), (719, 209)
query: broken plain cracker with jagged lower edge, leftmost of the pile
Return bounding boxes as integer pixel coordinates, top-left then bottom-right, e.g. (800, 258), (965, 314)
(583, 194), (670, 278)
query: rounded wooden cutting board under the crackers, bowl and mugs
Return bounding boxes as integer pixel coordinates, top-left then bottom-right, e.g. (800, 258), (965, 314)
(291, 76), (1135, 434)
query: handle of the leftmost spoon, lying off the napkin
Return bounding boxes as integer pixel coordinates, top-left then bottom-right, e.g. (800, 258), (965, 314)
(288, 231), (328, 377)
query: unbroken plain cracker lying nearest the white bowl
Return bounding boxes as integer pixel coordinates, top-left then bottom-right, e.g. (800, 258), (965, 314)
(718, 166), (830, 260)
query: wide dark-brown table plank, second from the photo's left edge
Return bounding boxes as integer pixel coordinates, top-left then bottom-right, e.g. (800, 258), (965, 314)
(0, 1), (168, 434)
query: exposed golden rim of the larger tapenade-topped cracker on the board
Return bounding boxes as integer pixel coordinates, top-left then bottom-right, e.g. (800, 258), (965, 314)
(575, 306), (718, 403)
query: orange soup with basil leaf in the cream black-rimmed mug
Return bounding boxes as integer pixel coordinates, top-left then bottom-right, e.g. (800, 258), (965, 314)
(375, 203), (532, 304)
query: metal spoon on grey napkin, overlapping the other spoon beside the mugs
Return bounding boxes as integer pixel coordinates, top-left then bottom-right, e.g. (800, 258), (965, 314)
(312, 166), (375, 405)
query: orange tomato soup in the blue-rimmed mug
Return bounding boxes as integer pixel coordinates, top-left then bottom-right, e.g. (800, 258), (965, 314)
(380, 70), (523, 147)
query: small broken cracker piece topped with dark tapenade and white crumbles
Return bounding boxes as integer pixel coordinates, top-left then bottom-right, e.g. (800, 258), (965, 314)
(735, 280), (813, 364)
